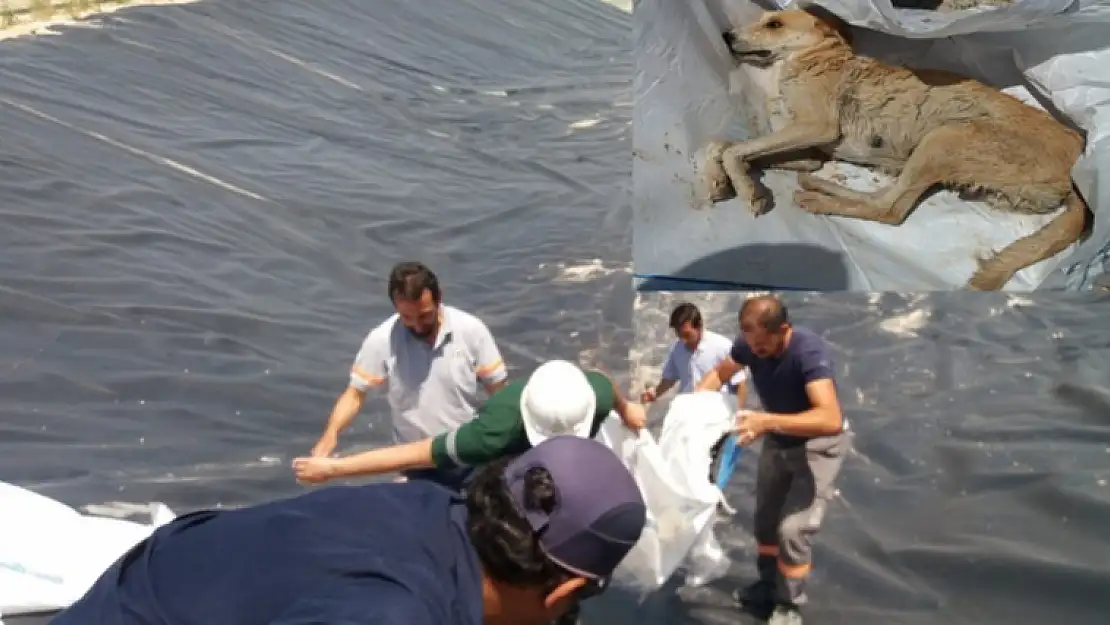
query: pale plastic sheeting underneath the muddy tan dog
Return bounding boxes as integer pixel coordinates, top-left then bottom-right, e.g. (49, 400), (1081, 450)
(633, 0), (1110, 291)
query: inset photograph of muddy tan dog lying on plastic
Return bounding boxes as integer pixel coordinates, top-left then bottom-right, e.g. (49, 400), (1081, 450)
(633, 0), (1110, 292)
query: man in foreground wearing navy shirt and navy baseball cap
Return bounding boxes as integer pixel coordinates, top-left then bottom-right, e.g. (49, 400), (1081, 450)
(51, 436), (647, 625)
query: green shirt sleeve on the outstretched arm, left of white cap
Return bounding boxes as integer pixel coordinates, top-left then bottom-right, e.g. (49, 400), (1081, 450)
(432, 381), (531, 468)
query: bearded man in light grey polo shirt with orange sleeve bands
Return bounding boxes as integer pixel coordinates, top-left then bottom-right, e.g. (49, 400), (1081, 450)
(312, 262), (508, 486)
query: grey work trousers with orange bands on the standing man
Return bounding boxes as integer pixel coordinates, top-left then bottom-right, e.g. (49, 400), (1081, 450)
(755, 431), (852, 605)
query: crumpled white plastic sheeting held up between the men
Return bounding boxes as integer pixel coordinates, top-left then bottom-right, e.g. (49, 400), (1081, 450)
(597, 392), (735, 594)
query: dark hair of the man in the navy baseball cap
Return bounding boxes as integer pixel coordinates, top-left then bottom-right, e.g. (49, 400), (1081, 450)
(466, 457), (568, 592)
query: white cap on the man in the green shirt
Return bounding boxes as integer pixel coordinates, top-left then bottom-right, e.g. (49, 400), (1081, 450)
(521, 360), (597, 446)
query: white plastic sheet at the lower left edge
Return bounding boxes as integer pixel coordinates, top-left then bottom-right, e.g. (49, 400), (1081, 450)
(0, 482), (174, 624)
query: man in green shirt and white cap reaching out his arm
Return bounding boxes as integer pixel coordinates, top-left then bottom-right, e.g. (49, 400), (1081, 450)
(293, 360), (646, 483)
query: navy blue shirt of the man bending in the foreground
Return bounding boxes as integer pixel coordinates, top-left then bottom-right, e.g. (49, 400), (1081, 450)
(51, 482), (482, 625)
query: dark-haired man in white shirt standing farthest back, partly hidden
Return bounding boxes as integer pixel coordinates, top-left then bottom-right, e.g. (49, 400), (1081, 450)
(640, 302), (748, 409)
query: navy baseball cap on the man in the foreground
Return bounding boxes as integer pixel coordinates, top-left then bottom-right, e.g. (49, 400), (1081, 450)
(504, 435), (647, 581)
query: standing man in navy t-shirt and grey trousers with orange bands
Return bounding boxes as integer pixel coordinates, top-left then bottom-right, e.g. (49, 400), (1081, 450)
(697, 295), (850, 625)
